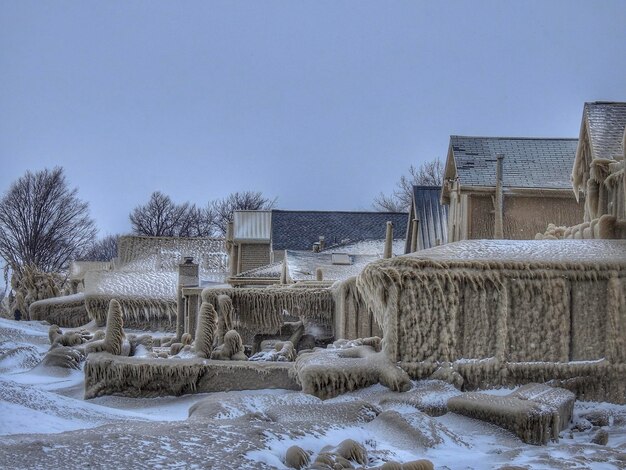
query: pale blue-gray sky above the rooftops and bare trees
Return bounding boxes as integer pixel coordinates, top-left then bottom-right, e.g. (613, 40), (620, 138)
(0, 0), (626, 235)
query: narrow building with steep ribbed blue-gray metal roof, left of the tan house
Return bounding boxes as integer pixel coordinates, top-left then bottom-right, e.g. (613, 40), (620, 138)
(404, 186), (448, 253)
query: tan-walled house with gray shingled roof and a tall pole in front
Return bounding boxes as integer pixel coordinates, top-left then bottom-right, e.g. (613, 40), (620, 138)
(441, 135), (583, 242)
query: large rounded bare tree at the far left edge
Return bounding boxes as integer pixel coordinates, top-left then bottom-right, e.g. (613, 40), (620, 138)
(0, 167), (96, 275)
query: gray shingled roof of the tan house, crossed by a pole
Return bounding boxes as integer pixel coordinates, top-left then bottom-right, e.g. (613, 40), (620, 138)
(450, 135), (578, 189)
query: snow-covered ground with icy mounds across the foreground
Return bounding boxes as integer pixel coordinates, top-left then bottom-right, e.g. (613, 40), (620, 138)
(0, 320), (626, 469)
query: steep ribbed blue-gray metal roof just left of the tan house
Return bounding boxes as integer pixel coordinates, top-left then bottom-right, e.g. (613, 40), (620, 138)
(405, 186), (448, 253)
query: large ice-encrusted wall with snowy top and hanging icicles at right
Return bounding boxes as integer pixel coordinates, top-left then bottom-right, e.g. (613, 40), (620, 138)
(357, 240), (626, 363)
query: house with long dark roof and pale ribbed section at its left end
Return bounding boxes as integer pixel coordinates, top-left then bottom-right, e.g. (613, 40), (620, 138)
(227, 210), (407, 276)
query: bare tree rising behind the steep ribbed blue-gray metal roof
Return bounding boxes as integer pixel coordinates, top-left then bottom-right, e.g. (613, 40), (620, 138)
(372, 158), (444, 212)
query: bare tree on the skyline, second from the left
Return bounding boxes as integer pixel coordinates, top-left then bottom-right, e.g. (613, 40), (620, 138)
(130, 191), (213, 237)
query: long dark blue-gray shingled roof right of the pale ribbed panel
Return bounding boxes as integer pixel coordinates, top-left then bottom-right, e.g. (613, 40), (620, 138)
(272, 210), (408, 251)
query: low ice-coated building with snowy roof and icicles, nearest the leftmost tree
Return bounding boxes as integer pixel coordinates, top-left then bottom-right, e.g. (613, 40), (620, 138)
(30, 235), (228, 329)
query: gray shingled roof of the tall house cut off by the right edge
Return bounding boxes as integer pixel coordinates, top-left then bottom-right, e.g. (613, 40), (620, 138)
(583, 101), (626, 159)
